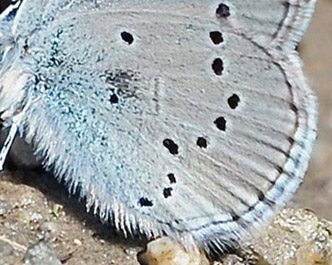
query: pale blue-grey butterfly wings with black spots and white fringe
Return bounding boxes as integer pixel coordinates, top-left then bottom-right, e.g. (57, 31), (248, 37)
(0, 0), (317, 255)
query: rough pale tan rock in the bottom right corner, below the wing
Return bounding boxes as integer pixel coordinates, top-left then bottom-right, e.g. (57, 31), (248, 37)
(222, 208), (332, 265)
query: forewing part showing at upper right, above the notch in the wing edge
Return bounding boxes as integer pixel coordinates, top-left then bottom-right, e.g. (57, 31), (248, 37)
(217, 0), (316, 49)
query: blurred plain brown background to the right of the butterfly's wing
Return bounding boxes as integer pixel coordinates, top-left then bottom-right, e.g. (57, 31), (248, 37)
(294, 0), (332, 220)
